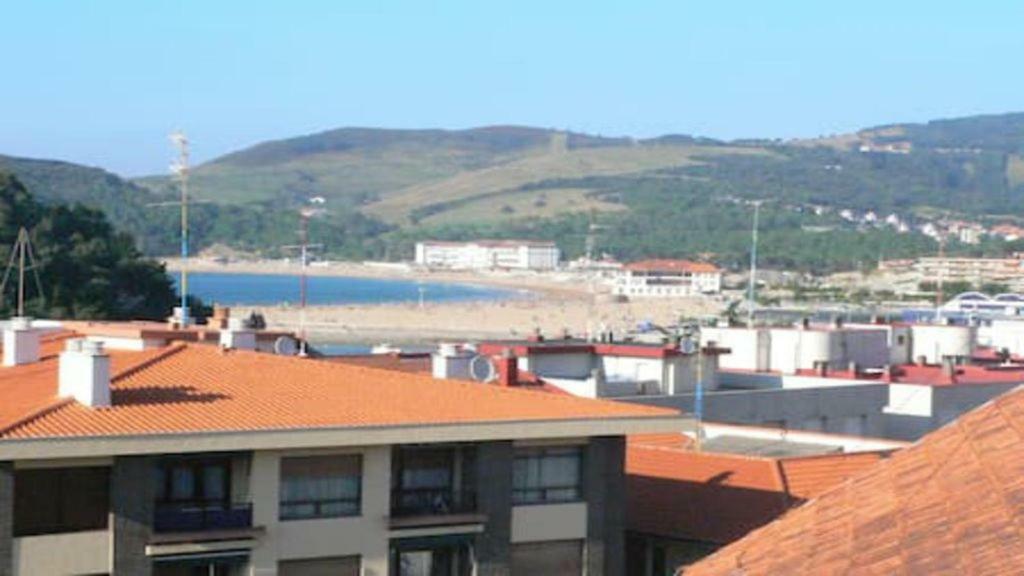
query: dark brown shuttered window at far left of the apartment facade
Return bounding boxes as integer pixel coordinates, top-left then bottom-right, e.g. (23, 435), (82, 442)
(14, 467), (111, 536)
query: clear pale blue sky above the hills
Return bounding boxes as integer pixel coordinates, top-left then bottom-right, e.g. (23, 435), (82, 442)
(0, 0), (1024, 175)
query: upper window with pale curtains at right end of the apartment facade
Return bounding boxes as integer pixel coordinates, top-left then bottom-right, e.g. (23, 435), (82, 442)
(512, 447), (583, 504)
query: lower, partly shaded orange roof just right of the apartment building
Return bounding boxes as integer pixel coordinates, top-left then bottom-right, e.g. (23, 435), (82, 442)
(626, 435), (887, 544)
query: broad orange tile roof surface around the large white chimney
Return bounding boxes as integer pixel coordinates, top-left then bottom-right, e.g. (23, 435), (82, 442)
(0, 343), (678, 439)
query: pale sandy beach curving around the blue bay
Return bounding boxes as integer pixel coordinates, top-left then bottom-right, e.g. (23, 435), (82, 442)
(168, 260), (724, 343)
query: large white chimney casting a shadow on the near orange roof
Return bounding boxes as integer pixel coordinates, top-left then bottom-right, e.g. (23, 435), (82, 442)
(57, 338), (111, 407)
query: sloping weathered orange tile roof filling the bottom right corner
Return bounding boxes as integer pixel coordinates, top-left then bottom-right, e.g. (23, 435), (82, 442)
(684, 388), (1024, 576)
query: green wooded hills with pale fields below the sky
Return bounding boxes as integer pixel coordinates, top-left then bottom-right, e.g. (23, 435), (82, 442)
(6, 114), (1024, 271)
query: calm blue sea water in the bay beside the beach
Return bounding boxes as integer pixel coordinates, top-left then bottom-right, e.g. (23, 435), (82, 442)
(171, 272), (523, 305)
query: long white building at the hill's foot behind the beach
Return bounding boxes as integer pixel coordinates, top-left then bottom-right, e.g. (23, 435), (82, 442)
(416, 240), (561, 270)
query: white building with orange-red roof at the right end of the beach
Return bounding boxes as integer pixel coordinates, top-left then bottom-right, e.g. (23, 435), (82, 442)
(612, 260), (722, 297)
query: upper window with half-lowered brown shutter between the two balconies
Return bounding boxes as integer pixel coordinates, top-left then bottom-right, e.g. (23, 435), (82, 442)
(281, 454), (362, 520)
